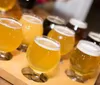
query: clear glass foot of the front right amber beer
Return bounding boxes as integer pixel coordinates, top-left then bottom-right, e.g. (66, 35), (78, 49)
(65, 70), (88, 83)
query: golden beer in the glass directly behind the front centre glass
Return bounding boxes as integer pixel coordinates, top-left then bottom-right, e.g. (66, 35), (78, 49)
(48, 29), (75, 55)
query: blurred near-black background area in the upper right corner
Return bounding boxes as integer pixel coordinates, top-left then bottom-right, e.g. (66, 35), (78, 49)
(86, 0), (100, 33)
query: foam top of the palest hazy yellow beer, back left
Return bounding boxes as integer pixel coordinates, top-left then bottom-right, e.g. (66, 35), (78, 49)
(22, 14), (43, 24)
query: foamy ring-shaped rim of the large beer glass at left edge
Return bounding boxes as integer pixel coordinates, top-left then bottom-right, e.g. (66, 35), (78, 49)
(0, 17), (22, 29)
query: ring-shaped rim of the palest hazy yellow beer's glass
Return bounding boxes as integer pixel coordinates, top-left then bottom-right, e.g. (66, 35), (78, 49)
(22, 14), (43, 24)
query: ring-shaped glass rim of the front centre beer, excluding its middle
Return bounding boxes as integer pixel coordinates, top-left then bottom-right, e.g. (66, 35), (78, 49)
(34, 35), (60, 51)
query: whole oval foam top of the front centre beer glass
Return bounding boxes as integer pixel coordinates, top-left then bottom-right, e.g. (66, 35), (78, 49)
(35, 37), (60, 51)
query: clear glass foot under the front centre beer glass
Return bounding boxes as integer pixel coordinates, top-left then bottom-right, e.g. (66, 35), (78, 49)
(22, 67), (48, 83)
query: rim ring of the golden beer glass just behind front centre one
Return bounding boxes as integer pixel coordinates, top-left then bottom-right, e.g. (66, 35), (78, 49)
(53, 25), (75, 37)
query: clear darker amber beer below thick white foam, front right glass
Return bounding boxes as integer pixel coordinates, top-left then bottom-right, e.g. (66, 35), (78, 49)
(70, 49), (100, 78)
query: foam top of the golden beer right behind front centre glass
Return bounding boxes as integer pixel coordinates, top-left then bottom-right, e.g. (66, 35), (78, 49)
(54, 25), (75, 36)
